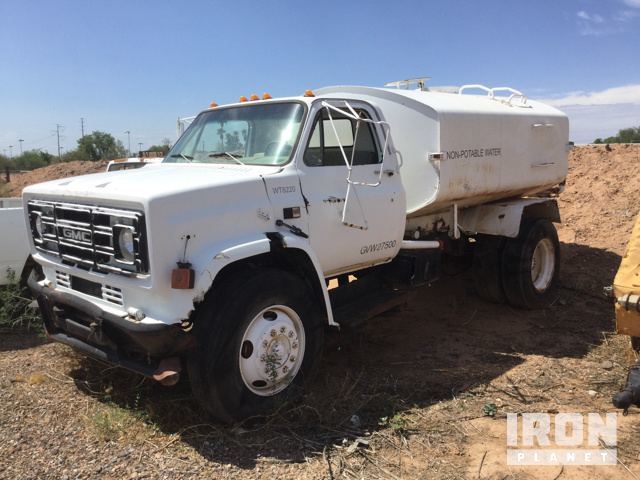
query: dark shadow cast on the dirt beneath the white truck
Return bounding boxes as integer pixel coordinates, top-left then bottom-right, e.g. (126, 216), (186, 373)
(66, 240), (620, 469)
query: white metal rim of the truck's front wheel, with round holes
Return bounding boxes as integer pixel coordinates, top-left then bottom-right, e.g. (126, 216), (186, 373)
(239, 305), (305, 397)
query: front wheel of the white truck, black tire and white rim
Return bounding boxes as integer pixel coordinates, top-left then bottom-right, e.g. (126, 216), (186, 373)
(189, 269), (324, 422)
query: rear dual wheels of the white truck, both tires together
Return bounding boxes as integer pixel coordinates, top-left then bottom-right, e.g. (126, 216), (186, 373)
(473, 219), (560, 309)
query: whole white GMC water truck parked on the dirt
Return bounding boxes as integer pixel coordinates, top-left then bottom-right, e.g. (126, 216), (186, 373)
(23, 82), (570, 421)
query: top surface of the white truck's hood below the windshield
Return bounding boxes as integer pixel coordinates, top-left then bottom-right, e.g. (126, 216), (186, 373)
(23, 163), (279, 203)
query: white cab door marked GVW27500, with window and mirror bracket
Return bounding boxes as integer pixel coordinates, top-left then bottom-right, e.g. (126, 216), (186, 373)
(297, 100), (405, 276)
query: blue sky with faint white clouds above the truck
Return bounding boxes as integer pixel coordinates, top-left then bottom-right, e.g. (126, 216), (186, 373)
(0, 0), (640, 155)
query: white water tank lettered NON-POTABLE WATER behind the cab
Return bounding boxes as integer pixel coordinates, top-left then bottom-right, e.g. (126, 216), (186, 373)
(316, 86), (569, 217)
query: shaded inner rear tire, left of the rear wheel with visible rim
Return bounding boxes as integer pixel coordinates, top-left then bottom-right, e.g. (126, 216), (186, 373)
(471, 235), (506, 303)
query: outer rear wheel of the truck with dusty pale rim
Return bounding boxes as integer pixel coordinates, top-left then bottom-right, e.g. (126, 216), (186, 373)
(501, 219), (560, 309)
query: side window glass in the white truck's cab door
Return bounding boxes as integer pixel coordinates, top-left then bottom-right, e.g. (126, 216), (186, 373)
(304, 109), (380, 167)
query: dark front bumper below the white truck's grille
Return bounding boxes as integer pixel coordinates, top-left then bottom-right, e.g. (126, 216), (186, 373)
(28, 277), (195, 377)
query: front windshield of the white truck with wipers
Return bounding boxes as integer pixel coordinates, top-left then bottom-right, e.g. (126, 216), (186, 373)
(164, 102), (305, 165)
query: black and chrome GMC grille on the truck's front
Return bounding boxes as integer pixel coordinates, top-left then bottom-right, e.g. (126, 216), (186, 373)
(27, 200), (148, 275)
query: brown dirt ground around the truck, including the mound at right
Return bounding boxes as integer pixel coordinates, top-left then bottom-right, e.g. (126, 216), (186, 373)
(0, 145), (640, 480)
